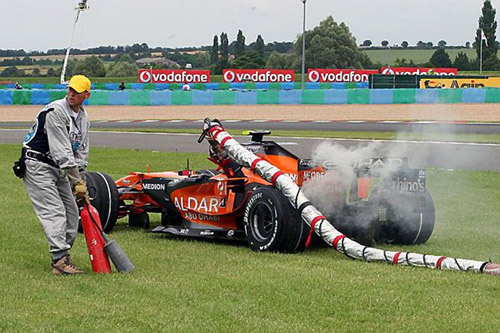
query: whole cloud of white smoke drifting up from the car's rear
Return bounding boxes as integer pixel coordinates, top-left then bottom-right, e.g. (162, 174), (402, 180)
(296, 105), (491, 246)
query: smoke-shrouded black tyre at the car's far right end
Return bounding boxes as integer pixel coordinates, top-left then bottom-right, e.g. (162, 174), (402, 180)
(373, 189), (435, 245)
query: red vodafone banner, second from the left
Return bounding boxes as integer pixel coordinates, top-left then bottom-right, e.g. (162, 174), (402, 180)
(222, 69), (295, 82)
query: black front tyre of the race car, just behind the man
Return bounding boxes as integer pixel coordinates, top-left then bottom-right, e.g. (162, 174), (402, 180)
(85, 172), (119, 233)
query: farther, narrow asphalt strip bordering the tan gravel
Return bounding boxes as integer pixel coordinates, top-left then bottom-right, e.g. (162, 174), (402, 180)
(0, 119), (500, 135)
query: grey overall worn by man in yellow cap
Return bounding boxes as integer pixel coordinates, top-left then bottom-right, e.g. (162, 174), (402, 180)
(23, 98), (90, 260)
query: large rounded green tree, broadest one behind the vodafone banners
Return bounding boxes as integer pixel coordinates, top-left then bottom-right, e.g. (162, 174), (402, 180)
(293, 16), (371, 70)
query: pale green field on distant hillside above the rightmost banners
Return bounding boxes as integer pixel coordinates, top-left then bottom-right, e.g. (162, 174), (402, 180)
(363, 48), (477, 66)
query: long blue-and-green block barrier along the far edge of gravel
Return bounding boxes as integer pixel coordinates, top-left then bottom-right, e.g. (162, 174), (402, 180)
(0, 88), (500, 106)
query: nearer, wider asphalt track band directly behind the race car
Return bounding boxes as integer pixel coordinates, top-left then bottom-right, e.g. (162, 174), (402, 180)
(0, 129), (500, 171)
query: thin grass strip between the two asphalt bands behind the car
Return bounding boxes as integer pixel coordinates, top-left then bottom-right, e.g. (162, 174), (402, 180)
(92, 125), (500, 143)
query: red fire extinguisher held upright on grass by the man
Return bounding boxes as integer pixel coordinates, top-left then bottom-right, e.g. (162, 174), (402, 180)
(80, 203), (111, 273)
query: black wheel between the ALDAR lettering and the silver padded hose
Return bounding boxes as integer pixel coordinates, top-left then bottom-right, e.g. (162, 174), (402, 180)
(243, 186), (309, 253)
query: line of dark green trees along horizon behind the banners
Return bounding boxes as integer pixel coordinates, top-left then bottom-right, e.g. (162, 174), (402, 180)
(0, 0), (500, 77)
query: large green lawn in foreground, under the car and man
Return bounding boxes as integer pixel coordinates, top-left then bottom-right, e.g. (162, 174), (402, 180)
(0, 144), (500, 332)
